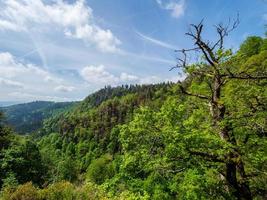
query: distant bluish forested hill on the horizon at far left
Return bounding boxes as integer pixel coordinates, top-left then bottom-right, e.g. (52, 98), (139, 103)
(0, 101), (77, 134)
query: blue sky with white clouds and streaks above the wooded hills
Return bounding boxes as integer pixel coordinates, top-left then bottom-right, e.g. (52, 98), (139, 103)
(0, 0), (267, 102)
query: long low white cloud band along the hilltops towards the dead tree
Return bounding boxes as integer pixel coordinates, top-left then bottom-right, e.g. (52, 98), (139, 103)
(0, 52), (182, 101)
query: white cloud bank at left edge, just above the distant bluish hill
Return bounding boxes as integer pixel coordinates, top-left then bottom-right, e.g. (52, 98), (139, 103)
(0, 52), (77, 101)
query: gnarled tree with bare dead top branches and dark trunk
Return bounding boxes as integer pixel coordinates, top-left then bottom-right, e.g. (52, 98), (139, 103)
(173, 16), (267, 200)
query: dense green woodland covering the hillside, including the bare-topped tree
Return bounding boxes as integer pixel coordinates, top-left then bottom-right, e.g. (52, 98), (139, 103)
(0, 23), (267, 200)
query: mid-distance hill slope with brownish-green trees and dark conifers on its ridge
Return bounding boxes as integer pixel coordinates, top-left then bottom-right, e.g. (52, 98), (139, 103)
(39, 83), (174, 138)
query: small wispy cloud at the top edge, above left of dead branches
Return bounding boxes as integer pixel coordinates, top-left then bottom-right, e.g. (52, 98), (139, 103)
(156, 0), (185, 18)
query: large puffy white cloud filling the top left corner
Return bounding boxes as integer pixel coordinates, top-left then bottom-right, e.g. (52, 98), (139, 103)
(0, 0), (121, 52)
